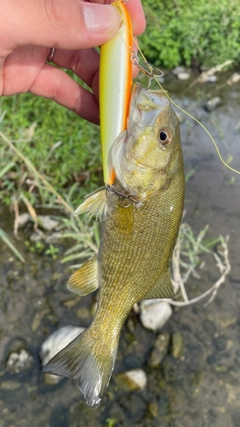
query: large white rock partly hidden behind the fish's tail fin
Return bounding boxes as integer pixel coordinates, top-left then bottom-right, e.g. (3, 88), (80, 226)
(40, 325), (84, 384)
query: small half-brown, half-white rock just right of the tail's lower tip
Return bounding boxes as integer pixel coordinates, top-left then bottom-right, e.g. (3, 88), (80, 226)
(115, 369), (147, 391)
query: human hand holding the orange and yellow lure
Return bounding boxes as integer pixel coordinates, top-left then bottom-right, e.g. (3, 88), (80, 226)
(0, 0), (145, 123)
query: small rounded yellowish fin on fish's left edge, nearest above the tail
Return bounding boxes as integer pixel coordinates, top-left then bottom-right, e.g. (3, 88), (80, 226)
(67, 255), (98, 295)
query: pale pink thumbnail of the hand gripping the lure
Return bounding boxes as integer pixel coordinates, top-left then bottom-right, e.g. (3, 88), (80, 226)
(83, 4), (121, 33)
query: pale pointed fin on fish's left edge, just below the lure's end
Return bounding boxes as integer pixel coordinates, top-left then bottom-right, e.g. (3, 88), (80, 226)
(74, 187), (107, 221)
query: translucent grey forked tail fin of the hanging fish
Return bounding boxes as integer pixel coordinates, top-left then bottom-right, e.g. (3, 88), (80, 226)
(43, 328), (118, 407)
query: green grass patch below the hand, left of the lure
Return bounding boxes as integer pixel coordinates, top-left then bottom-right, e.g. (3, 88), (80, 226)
(0, 94), (101, 204)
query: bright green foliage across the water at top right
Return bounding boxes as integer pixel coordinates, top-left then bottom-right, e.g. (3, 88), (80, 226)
(140, 0), (240, 68)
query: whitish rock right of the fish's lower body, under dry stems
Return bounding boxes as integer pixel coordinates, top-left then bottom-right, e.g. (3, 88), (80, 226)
(140, 300), (172, 331)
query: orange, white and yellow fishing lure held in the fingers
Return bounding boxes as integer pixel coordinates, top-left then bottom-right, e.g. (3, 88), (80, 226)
(99, 0), (133, 185)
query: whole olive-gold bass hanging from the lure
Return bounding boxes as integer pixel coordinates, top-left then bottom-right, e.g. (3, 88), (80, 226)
(44, 84), (185, 407)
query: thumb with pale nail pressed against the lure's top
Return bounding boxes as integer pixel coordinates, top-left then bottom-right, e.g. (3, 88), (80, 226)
(0, 0), (121, 49)
